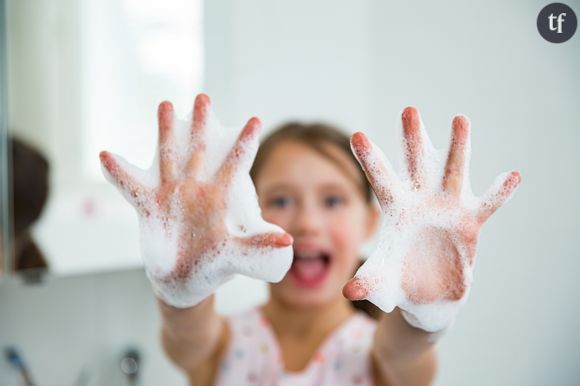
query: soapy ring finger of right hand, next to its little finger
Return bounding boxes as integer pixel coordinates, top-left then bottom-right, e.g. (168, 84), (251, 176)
(443, 115), (470, 196)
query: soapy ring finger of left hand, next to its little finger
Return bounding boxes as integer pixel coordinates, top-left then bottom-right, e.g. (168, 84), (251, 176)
(157, 102), (177, 184)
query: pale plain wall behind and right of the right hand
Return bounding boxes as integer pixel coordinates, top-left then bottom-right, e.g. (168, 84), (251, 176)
(364, 1), (580, 386)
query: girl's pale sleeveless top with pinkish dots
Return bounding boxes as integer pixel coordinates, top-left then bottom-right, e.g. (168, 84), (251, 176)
(216, 308), (376, 386)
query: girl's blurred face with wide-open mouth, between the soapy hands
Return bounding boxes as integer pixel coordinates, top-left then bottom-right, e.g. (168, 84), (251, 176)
(256, 140), (378, 307)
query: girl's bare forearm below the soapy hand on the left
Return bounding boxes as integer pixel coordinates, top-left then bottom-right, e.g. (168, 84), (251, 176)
(158, 295), (225, 372)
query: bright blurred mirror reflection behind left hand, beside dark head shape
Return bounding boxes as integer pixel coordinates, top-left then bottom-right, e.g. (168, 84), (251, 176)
(6, 0), (203, 275)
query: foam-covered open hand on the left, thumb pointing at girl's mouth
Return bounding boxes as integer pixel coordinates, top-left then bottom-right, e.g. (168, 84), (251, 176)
(100, 94), (292, 307)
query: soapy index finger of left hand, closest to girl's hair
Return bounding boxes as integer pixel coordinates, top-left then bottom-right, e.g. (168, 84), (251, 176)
(216, 117), (260, 186)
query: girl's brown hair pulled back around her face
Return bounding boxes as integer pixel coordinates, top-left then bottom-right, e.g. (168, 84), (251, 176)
(250, 122), (381, 319)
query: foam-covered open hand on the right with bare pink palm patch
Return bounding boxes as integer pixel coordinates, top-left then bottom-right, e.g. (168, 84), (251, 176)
(343, 107), (521, 332)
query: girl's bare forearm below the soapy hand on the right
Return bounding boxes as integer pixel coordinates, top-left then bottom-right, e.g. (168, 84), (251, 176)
(372, 308), (436, 386)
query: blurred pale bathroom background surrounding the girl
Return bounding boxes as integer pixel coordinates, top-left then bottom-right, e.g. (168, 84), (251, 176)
(0, 0), (580, 386)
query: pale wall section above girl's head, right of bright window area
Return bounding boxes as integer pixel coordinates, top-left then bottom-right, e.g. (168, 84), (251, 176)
(205, 0), (373, 136)
